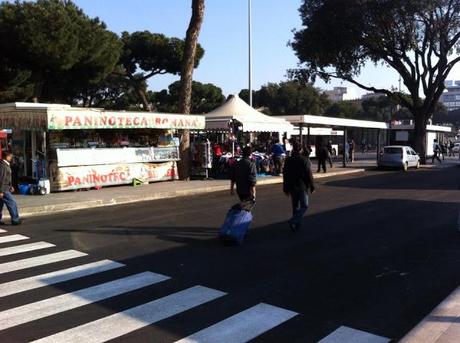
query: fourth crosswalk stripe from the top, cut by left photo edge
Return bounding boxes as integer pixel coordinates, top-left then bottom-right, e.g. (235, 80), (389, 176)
(0, 260), (125, 297)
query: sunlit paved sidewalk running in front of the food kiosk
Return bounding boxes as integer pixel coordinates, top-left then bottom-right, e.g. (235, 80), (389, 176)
(3, 168), (364, 218)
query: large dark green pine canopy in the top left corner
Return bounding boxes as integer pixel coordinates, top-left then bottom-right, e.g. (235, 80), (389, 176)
(0, 0), (121, 101)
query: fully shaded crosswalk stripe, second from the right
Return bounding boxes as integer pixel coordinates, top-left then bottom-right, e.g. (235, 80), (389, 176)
(176, 304), (297, 343)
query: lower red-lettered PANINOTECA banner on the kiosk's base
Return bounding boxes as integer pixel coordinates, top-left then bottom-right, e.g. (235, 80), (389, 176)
(51, 162), (178, 191)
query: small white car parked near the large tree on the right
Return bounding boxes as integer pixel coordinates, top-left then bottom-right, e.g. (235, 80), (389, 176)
(378, 145), (420, 171)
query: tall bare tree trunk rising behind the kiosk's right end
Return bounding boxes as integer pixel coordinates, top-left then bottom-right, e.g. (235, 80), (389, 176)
(178, 0), (204, 180)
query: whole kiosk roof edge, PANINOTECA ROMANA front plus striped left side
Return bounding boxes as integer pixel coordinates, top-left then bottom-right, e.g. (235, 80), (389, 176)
(0, 102), (205, 130)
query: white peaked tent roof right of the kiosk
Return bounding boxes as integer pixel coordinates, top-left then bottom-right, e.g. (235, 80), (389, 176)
(206, 95), (293, 132)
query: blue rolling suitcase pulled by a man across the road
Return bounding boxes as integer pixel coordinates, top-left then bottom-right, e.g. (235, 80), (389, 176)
(219, 201), (254, 244)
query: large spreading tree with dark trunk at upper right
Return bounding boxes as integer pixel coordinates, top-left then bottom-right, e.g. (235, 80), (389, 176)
(291, 0), (460, 158)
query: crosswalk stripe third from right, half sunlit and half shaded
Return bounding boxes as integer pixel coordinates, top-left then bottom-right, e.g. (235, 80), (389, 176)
(35, 286), (226, 343)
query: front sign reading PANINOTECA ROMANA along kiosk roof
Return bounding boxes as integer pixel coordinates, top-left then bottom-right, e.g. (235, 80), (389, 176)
(48, 110), (205, 130)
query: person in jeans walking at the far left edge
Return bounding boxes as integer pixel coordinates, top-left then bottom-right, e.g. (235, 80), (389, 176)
(0, 151), (22, 225)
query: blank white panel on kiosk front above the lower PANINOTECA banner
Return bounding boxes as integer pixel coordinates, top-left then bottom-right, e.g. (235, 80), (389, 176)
(56, 146), (179, 167)
